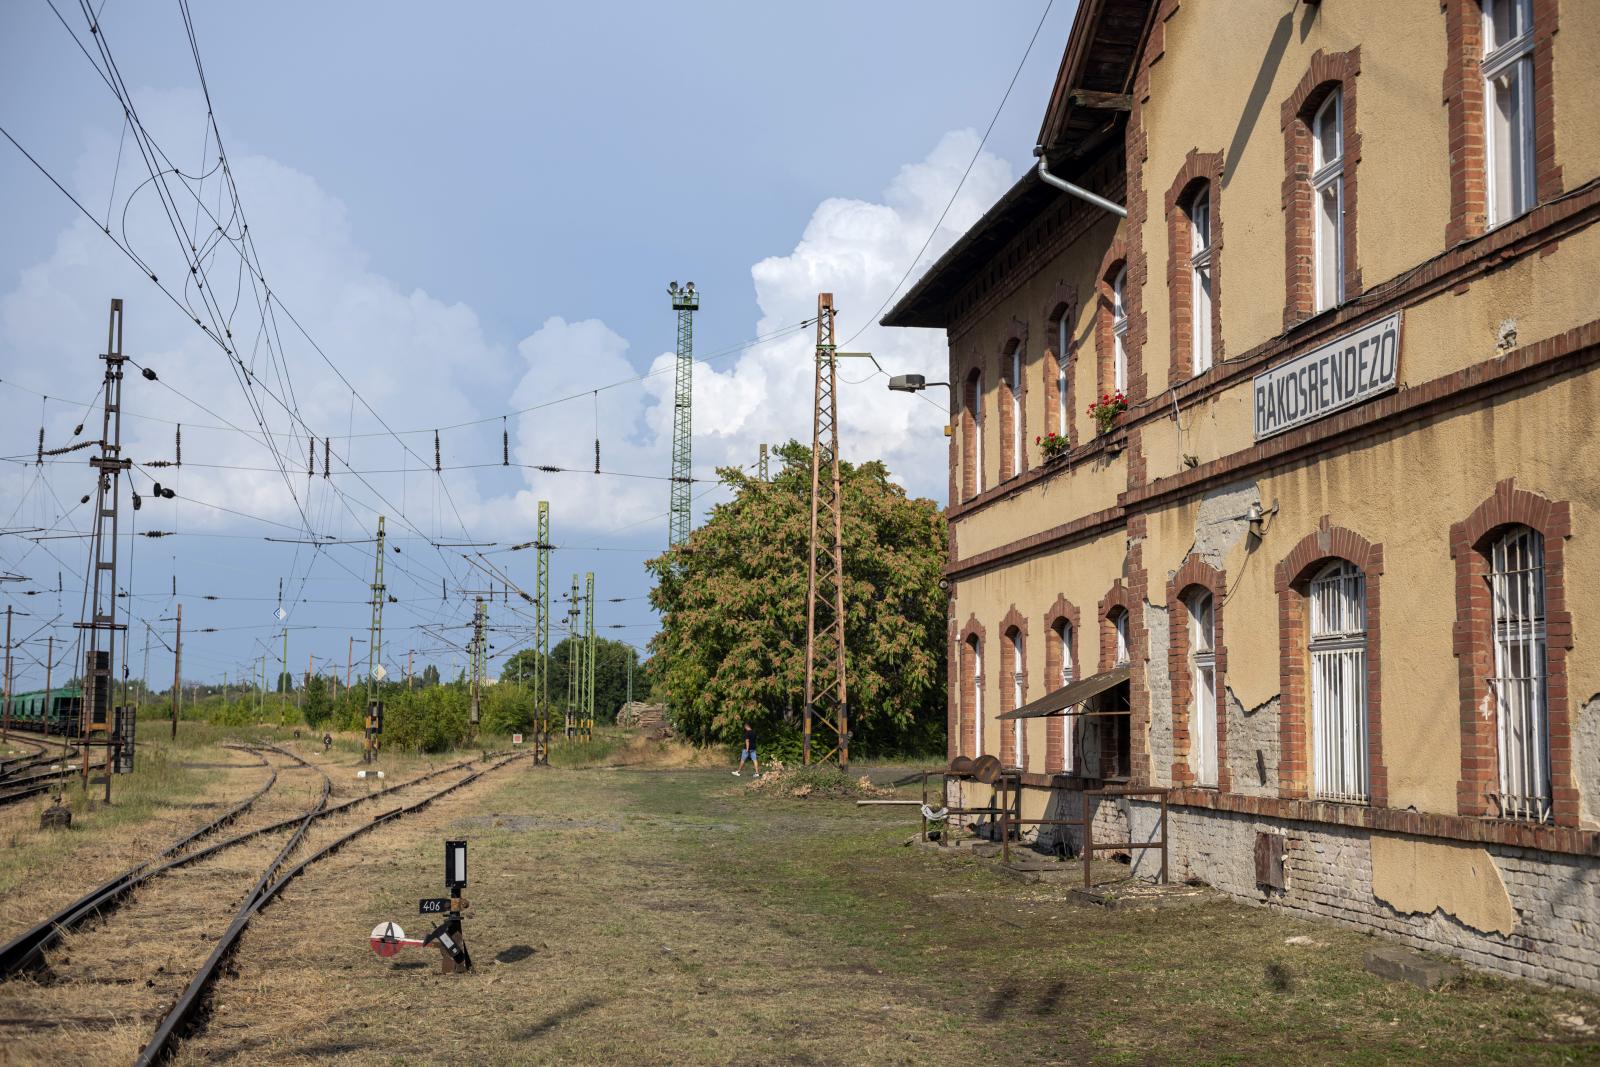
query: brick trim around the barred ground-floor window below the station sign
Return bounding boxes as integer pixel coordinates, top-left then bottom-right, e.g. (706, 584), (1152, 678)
(1274, 515), (1389, 808)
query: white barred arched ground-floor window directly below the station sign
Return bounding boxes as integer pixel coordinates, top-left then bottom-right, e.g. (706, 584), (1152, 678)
(1310, 560), (1368, 803)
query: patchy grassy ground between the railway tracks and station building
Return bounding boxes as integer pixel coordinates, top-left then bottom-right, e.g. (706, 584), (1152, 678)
(162, 752), (1600, 1064)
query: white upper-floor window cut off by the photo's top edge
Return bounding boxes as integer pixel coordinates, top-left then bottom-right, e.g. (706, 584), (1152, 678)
(1483, 0), (1534, 226)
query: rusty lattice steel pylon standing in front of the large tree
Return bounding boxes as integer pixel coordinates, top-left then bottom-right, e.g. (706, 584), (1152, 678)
(800, 293), (850, 768)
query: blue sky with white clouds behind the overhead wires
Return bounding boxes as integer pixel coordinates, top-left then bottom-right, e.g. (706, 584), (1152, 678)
(0, 0), (1074, 688)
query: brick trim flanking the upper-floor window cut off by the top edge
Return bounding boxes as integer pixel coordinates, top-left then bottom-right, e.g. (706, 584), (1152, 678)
(1440, 0), (1562, 246)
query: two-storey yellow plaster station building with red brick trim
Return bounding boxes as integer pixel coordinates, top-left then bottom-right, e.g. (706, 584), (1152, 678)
(885, 0), (1600, 990)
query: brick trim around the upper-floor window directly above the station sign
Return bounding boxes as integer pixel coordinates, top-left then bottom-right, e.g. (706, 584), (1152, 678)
(1280, 45), (1362, 328)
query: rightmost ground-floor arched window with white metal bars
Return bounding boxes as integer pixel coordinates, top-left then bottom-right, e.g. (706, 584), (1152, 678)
(1490, 526), (1550, 822)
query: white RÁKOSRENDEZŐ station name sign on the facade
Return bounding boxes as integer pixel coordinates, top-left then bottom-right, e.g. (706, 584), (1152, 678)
(1254, 312), (1400, 442)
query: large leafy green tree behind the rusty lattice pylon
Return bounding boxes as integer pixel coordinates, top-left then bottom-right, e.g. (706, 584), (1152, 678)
(648, 442), (946, 752)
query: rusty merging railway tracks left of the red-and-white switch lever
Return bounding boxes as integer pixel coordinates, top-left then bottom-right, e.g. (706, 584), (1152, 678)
(0, 750), (518, 1064)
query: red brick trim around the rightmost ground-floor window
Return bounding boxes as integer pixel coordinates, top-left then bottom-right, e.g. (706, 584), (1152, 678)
(1450, 478), (1579, 827)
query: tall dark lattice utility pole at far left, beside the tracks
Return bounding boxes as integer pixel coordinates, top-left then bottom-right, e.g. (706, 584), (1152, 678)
(74, 299), (131, 803)
